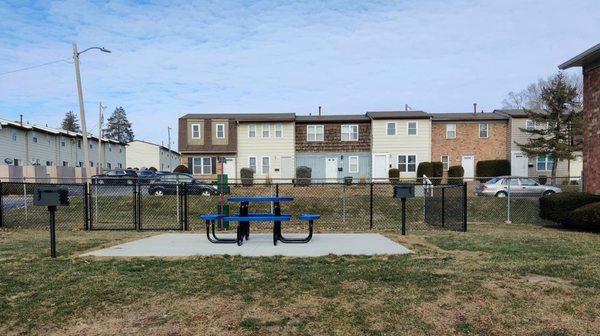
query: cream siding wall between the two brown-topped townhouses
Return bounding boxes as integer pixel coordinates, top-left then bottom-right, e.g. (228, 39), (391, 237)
(236, 122), (295, 178)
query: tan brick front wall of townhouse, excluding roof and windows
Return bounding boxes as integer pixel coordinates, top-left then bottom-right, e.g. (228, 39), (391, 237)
(431, 121), (507, 172)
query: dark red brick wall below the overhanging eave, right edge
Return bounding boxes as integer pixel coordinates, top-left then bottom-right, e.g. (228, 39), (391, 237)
(583, 67), (600, 194)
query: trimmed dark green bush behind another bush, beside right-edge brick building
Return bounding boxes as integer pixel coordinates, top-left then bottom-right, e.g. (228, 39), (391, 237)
(540, 192), (600, 226)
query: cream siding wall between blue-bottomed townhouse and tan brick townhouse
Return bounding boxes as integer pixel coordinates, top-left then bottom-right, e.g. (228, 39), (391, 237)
(371, 119), (431, 178)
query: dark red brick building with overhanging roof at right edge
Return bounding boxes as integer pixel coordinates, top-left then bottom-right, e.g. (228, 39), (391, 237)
(559, 44), (600, 194)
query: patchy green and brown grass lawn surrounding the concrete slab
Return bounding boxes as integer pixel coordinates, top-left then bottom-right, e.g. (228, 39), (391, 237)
(0, 224), (600, 335)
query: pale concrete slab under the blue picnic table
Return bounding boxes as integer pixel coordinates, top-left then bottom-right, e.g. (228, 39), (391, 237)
(81, 233), (411, 257)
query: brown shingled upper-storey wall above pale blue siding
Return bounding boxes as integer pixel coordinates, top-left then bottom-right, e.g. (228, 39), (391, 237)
(296, 123), (371, 152)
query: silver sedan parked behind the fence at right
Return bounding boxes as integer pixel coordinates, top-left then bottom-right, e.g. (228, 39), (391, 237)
(475, 176), (562, 197)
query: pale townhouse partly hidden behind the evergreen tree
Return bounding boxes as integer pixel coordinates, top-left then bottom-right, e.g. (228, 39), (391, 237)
(494, 109), (583, 177)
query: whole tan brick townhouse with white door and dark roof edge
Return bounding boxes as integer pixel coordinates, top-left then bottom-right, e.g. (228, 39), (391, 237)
(430, 113), (508, 179)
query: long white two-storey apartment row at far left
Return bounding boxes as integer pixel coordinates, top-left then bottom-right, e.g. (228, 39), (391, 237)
(0, 119), (126, 169)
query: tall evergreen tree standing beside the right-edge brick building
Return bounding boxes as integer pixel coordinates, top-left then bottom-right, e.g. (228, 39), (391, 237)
(517, 73), (582, 181)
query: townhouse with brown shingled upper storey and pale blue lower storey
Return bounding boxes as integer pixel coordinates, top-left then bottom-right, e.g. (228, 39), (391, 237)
(295, 115), (372, 181)
